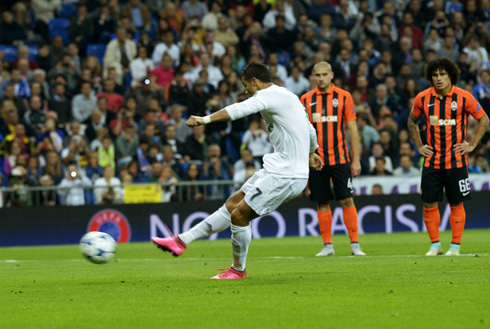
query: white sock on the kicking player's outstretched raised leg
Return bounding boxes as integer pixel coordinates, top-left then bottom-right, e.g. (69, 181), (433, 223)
(178, 205), (231, 245)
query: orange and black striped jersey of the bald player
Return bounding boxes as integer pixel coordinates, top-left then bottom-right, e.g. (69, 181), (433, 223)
(301, 83), (356, 166)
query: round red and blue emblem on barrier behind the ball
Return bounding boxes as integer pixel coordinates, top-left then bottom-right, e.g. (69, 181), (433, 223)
(88, 209), (131, 243)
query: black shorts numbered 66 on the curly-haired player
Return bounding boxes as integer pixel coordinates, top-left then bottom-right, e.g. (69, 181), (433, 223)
(421, 167), (471, 204)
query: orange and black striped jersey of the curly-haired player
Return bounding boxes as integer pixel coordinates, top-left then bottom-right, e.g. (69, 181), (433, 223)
(412, 86), (485, 169)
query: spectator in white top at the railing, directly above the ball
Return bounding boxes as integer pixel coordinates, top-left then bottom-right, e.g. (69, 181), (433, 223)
(58, 162), (92, 206)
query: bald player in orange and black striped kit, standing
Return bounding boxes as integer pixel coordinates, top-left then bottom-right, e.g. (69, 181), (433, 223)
(301, 62), (365, 256)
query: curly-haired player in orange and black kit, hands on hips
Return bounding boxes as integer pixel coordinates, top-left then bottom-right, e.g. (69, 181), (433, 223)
(408, 58), (489, 256)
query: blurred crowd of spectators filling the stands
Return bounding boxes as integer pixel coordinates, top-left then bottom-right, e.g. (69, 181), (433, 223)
(0, 0), (490, 205)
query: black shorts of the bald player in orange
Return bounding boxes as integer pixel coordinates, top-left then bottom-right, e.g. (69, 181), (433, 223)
(308, 164), (353, 202)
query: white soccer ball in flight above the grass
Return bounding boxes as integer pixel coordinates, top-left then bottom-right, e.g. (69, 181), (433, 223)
(80, 231), (117, 264)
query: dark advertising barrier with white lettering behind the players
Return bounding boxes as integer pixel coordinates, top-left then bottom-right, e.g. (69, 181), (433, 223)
(0, 192), (490, 246)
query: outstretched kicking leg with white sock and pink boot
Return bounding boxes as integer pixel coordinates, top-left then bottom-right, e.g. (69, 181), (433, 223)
(151, 191), (244, 257)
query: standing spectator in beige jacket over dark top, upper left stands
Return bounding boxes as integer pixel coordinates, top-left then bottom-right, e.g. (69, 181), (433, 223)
(104, 27), (136, 84)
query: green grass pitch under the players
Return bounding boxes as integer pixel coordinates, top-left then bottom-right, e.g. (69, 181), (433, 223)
(0, 229), (490, 329)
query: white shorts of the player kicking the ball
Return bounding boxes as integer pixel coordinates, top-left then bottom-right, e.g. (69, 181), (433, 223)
(241, 169), (308, 216)
